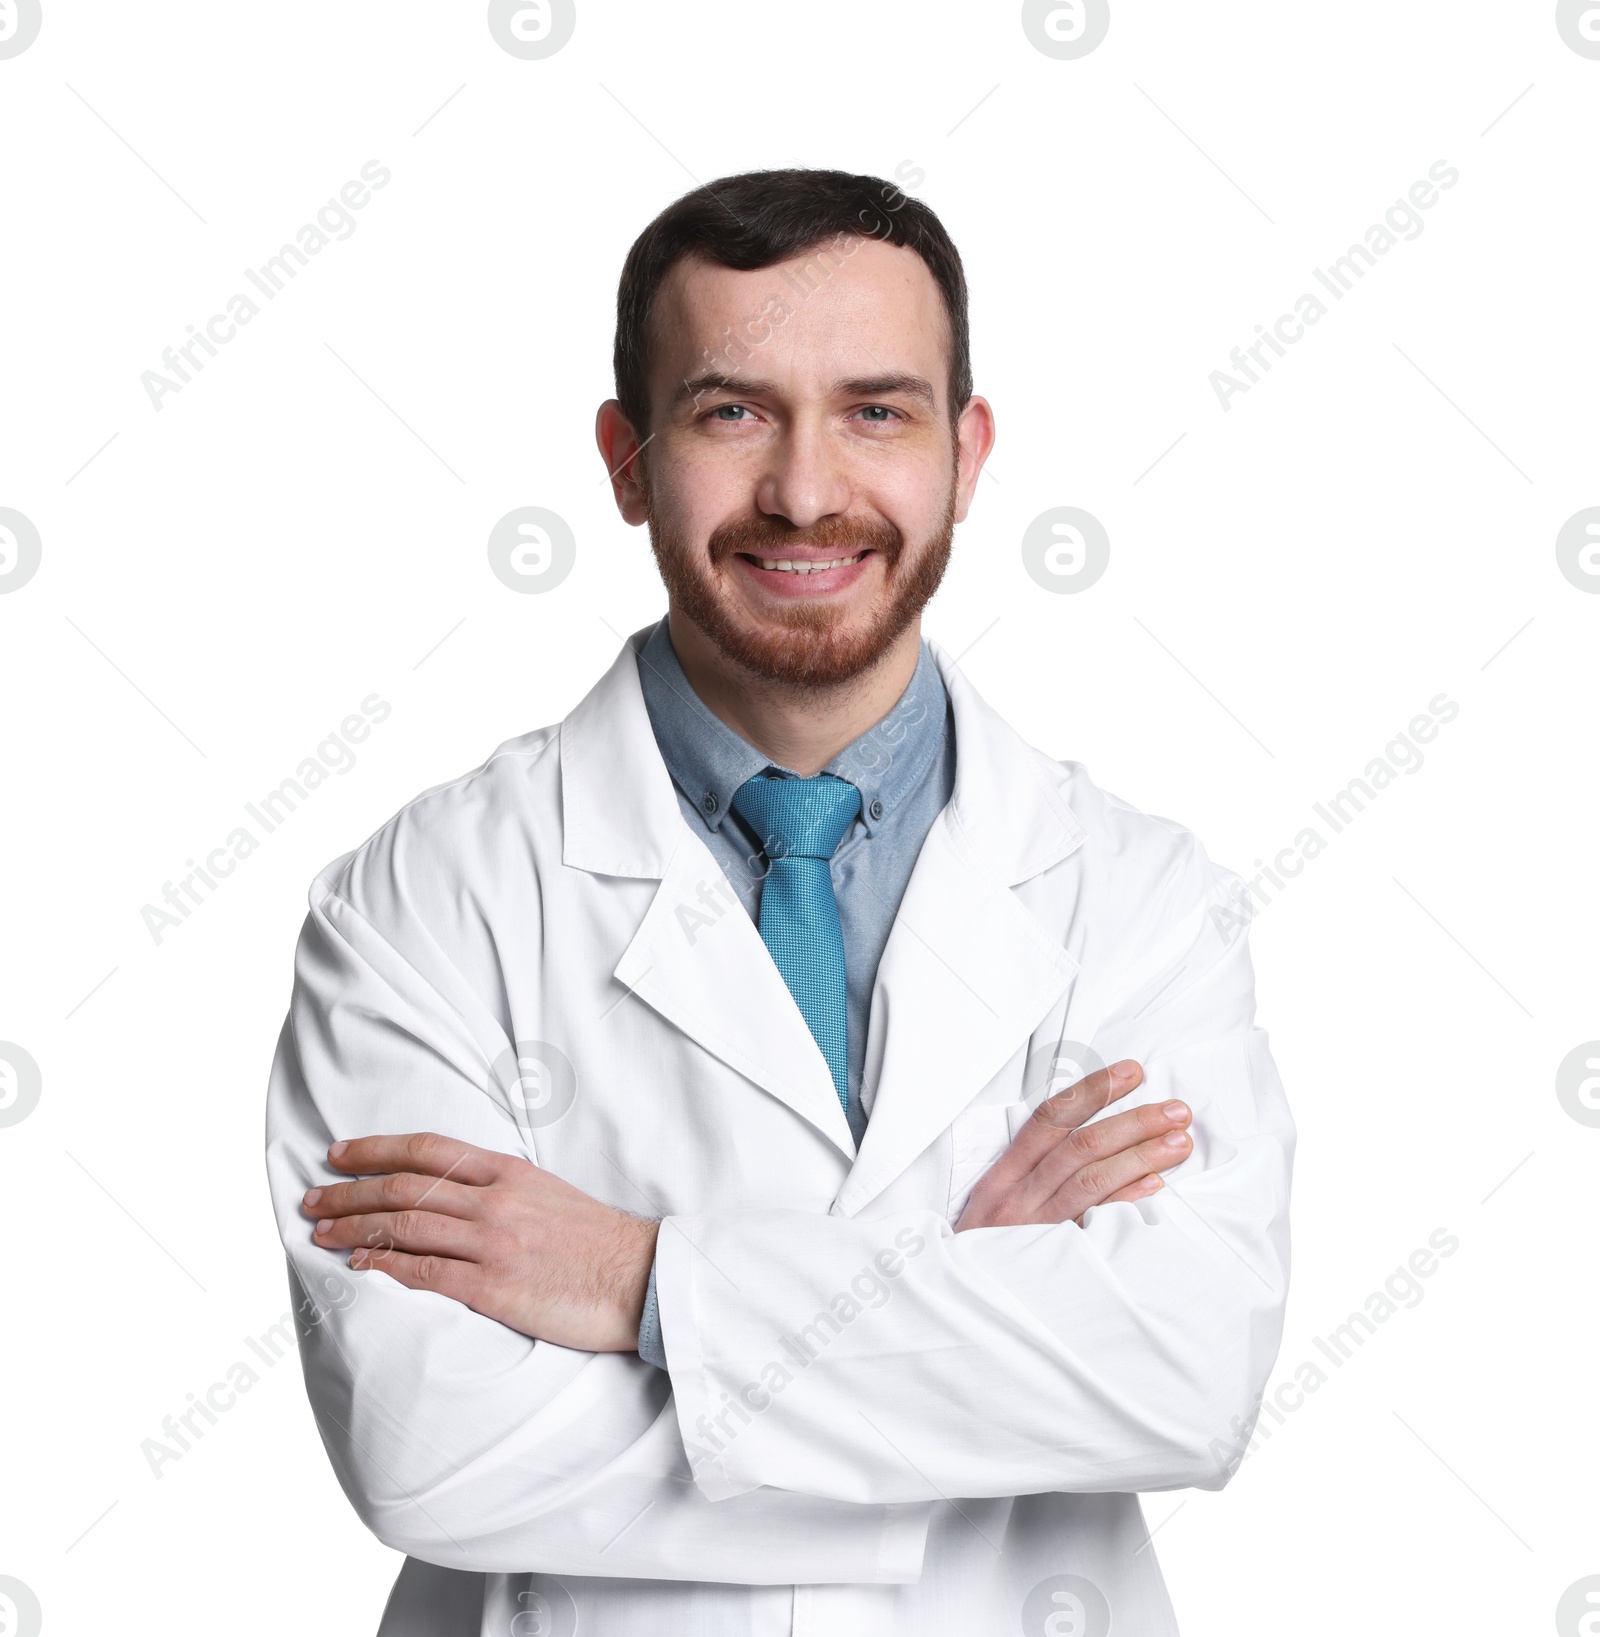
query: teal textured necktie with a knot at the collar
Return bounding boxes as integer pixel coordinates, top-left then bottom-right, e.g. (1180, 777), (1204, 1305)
(734, 773), (861, 1113)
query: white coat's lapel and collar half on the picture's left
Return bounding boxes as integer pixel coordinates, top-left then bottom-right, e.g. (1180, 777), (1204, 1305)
(560, 630), (855, 1159)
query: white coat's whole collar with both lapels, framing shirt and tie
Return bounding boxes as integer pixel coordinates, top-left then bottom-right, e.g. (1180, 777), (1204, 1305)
(560, 627), (1086, 1178)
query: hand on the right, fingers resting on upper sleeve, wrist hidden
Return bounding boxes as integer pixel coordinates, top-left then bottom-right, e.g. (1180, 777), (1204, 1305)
(955, 1058), (1194, 1233)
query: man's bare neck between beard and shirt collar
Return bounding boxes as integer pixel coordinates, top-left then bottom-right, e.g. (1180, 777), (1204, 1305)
(667, 609), (922, 779)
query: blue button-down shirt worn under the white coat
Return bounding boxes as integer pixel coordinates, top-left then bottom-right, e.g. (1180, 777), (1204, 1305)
(639, 619), (955, 1370)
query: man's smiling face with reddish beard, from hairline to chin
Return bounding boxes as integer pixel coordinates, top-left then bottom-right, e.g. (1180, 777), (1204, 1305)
(608, 239), (991, 688)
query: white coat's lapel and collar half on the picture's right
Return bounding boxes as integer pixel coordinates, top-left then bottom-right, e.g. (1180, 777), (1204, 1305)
(834, 645), (1086, 1215)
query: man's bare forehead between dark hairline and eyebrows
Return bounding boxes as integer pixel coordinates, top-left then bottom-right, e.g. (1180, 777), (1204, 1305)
(650, 237), (950, 403)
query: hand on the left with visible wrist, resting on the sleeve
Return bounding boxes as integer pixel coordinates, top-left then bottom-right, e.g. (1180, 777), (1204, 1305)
(303, 1131), (660, 1352)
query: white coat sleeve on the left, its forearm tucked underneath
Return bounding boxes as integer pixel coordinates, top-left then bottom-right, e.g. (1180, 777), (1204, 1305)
(267, 882), (927, 1585)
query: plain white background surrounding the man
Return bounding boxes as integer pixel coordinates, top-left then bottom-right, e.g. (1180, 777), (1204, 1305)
(0, 0), (1600, 1637)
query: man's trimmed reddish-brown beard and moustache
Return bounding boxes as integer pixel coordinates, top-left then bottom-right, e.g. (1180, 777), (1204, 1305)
(640, 467), (956, 688)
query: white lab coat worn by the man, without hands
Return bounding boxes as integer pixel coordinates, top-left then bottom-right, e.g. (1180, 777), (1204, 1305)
(258, 634), (1294, 1637)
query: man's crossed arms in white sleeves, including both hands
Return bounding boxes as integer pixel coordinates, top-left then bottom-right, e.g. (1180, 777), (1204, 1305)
(258, 870), (1294, 1583)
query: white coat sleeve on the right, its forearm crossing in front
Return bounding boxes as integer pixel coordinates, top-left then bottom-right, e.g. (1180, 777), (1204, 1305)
(657, 855), (1294, 1503)
